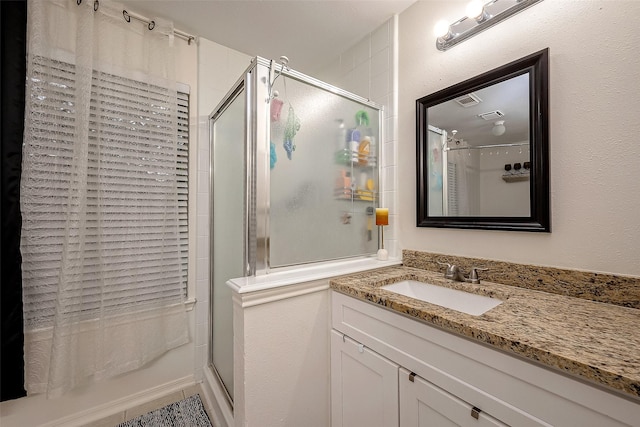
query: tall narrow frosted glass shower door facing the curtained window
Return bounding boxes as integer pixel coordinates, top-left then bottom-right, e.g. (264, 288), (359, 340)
(211, 90), (246, 399)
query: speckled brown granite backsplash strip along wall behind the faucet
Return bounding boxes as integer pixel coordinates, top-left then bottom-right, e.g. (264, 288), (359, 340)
(402, 250), (640, 310)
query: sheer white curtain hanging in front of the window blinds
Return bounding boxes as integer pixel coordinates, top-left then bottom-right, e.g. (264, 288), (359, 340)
(21, 0), (189, 397)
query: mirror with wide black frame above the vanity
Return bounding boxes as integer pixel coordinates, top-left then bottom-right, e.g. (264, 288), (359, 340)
(416, 49), (551, 232)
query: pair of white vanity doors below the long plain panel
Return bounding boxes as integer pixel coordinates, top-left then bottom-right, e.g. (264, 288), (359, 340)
(331, 330), (506, 427)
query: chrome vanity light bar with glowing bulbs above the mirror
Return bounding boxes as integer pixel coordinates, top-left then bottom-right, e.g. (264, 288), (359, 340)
(433, 0), (542, 51)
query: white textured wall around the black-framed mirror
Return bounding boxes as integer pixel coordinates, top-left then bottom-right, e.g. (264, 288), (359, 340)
(398, 0), (640, 275)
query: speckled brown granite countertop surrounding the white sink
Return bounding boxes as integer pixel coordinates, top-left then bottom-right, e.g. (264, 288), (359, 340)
(330, 266), (640, 398)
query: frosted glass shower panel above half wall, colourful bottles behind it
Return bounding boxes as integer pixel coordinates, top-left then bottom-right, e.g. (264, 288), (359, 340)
(269, 76), (380, 268)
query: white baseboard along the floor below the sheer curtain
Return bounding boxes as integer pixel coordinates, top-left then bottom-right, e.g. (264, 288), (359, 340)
(41, 375), (195, 427)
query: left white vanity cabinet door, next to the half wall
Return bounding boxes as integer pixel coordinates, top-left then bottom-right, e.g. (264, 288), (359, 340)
(331, 331), (399, 427)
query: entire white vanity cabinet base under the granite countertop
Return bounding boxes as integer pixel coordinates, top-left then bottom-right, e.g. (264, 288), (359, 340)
(331, 291), (640, 427)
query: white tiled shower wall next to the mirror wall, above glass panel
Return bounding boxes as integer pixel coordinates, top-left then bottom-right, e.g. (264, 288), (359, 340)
(318, 15), (401, 257)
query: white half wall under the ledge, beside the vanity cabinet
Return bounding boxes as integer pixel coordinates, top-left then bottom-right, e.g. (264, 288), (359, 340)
(234, 279), (330, 427)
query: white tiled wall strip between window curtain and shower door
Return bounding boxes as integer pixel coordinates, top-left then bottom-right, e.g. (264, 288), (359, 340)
(195, 38), (251, 381)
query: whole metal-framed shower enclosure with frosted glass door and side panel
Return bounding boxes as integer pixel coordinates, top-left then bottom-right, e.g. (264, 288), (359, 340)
(209, 57), (382, 402)
